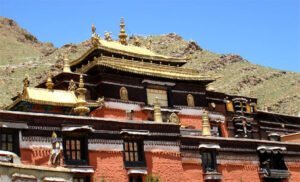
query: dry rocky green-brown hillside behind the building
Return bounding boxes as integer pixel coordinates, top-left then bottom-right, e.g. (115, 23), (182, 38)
(0, 17), (300, 115)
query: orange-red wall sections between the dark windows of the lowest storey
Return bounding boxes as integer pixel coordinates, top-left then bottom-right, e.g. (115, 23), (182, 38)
(21, 148), (300, 182)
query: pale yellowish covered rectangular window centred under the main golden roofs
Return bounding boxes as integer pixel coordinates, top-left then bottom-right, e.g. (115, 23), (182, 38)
(147, 88), (168, 106)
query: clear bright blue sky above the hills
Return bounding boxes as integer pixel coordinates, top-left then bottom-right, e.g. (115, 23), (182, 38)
(0, 0), (300, 72)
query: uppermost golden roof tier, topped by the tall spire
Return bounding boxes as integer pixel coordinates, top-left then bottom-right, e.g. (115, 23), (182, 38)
(70, 39), (187, 66)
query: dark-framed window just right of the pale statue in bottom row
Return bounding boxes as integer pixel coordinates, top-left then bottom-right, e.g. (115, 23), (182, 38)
(63, 137), (88, 165)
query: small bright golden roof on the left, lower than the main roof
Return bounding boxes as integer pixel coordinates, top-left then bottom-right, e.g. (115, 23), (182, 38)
(21, 87), (77, 107)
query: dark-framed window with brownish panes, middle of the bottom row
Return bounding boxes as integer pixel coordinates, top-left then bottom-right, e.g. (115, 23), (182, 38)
(124, 140), (146, 167)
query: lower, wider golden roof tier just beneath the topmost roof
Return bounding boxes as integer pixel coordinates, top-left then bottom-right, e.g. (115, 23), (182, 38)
(77, 56), (213, 81)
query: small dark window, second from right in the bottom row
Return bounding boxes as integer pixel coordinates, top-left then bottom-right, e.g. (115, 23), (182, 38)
(201, 150), (217, 173)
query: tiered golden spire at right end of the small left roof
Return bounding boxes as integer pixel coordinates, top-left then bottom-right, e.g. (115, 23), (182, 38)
(74, 75), (90, 116)
